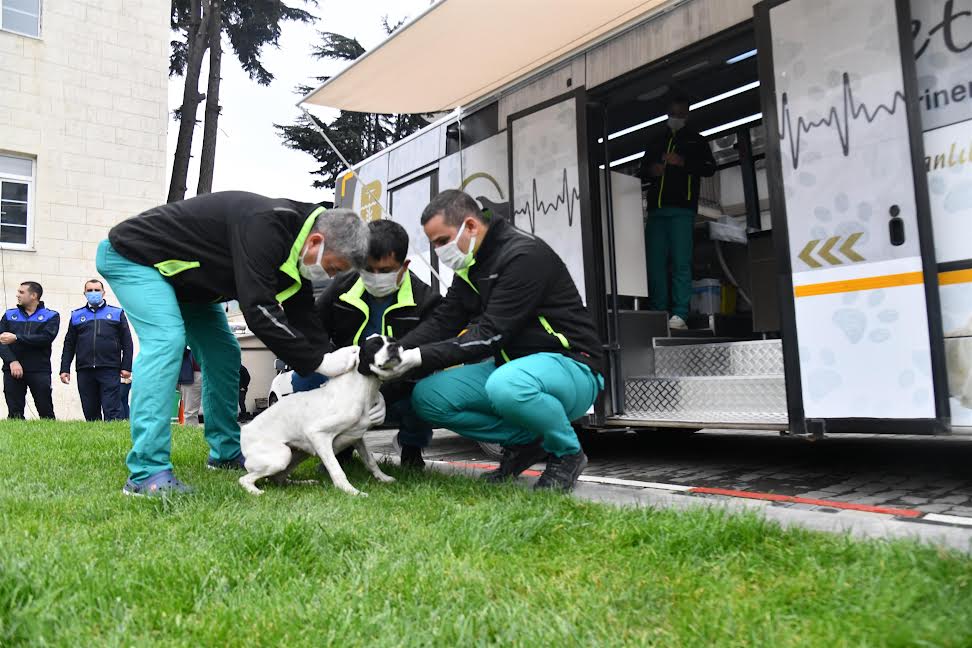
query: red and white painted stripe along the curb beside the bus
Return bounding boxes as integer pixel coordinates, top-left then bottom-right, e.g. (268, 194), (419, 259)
(426, 459), (972, 527)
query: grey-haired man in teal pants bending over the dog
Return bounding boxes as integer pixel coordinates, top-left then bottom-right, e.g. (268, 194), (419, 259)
(97, 191), (368, 495)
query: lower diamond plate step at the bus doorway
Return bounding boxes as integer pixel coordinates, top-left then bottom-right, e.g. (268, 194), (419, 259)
(624, 375), (787, 424)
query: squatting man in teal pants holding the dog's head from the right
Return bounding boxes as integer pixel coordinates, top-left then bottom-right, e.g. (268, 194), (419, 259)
(370, 190), (604, 491)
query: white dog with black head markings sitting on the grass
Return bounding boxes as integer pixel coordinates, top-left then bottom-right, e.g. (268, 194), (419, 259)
(240, 335), (401, 495)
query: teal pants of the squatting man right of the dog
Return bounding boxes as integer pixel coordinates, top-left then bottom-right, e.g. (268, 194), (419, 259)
(412, 353), (604, 457)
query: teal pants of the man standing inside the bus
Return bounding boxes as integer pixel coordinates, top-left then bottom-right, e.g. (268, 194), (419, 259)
(645, 207), (695, 319)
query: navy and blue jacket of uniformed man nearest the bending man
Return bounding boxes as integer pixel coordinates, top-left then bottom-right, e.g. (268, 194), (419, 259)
(60, 301), (132, 373)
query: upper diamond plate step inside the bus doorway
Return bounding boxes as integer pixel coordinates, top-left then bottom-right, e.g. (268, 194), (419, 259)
(655, 340), (783, 380)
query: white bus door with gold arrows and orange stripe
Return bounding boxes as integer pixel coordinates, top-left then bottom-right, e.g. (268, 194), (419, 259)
(755, 0), (949, 434)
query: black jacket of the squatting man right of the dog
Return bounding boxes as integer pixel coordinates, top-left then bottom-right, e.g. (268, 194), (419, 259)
(401, 218), (602, 373)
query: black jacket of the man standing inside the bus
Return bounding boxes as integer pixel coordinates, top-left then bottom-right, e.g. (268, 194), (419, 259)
(638, 128), (716, 211)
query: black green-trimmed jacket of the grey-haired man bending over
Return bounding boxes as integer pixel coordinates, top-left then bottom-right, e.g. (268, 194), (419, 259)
(108, 191), (331, 374)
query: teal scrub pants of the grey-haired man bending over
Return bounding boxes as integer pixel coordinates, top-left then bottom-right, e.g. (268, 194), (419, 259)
(96, 240), (240, 483)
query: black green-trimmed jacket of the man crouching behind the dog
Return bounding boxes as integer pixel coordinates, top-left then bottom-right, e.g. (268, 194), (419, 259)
(317, 271), (442, 402)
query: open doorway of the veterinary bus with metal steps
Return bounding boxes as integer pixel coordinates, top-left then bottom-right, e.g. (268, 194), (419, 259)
(588, 24), (787, 430)
